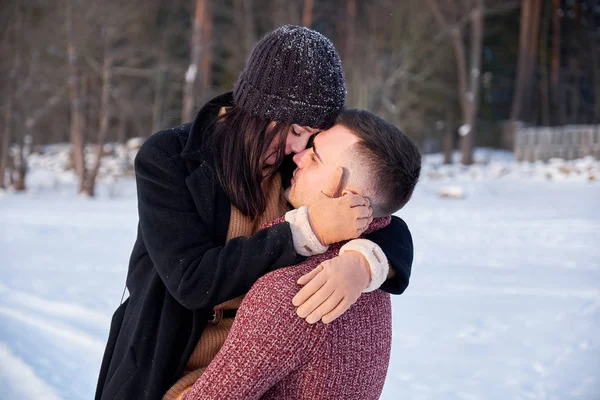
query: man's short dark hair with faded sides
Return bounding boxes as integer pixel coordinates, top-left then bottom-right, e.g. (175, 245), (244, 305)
(336, 109), (421, 216)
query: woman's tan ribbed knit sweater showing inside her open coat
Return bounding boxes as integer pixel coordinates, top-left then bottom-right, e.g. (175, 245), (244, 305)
(163, 174), (288, 400)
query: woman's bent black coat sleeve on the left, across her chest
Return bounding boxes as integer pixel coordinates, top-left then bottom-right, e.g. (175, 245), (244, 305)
(135, 134), (303, 310)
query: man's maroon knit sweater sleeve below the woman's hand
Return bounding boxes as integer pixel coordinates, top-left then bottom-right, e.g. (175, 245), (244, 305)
(184, 267), (327, 400)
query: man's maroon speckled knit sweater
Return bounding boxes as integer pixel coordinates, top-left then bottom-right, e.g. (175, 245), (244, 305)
(183, 217), (392, 400)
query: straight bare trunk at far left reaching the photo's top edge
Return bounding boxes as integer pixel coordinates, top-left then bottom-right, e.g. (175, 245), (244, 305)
(65, 0), (85, 189)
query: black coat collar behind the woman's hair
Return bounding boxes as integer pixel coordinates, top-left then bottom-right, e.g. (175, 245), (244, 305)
(181, 92), (233, 160)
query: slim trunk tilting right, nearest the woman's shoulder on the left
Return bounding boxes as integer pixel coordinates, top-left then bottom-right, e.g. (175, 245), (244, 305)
(82, 32), (114, 197)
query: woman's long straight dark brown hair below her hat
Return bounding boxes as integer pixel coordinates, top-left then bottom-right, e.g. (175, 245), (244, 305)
(206, 106), (291, 218)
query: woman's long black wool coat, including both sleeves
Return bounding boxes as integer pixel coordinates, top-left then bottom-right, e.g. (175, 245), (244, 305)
(95, 93), (413, 400)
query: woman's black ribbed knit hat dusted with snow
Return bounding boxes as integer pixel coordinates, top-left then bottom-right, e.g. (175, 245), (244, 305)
(233, 25), (346, 129)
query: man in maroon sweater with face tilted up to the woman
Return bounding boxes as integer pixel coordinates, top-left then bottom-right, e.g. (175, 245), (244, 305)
(183, 110), (421, 400)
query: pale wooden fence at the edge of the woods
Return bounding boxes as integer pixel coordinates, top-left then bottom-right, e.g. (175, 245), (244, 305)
(514, 125), (600, 161)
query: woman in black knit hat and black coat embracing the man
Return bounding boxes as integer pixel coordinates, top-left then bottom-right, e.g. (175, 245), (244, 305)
(96, 26), (412, 400)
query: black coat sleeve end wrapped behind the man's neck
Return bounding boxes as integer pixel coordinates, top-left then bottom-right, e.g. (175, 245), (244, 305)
(365, 216), (413, 294)
